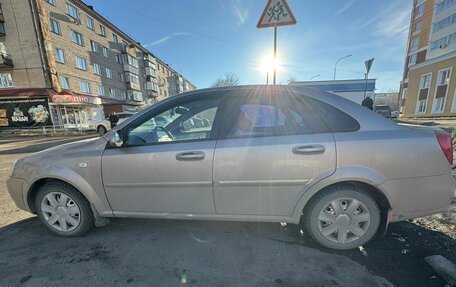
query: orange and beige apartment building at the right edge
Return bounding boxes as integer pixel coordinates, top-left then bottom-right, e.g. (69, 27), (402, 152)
(400, 0), (456, 118)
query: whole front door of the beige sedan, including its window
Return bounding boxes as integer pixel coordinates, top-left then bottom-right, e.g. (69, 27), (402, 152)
(102, 95), (224, 215)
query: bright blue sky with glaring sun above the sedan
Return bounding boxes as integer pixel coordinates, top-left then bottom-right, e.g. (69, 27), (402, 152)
(85, 0), (412, 92)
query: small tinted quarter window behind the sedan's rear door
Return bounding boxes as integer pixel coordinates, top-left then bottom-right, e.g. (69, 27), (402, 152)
(309, 98), (360, 133)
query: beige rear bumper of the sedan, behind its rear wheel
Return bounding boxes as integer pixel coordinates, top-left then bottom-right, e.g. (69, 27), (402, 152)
(380, 174), (456, 222)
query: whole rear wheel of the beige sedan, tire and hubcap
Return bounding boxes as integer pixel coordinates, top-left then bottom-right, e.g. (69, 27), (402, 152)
(303, 185), (381, 250)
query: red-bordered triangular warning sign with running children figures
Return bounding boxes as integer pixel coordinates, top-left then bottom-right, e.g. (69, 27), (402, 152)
(257, 0), (296, 28)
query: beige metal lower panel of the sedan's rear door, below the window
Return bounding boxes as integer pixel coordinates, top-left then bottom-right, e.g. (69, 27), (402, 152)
(214, 134), (336, 216)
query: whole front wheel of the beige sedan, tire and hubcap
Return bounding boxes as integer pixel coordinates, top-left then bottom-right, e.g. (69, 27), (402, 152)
(35, 181), (94, 237)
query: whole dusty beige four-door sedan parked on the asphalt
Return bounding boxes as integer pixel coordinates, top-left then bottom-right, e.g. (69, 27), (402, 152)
(7, 86), (455, 249)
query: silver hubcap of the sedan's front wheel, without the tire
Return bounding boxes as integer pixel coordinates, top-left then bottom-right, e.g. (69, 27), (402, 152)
(41, 192), (81, 232)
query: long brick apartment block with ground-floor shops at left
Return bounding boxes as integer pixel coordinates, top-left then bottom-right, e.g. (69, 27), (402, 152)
(0, 0), (194, 128)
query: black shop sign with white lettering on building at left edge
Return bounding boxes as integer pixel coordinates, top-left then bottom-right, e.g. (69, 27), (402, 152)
(0, 98), (52, 128)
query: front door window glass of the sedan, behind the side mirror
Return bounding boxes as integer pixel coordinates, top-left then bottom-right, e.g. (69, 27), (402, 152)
(127, 97), (220, 146)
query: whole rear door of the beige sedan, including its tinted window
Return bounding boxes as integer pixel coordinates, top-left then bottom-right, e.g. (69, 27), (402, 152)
(214, 90), (336, 217)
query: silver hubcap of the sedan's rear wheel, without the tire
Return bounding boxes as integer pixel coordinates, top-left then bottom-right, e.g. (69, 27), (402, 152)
(318, 198), (371, 244)
